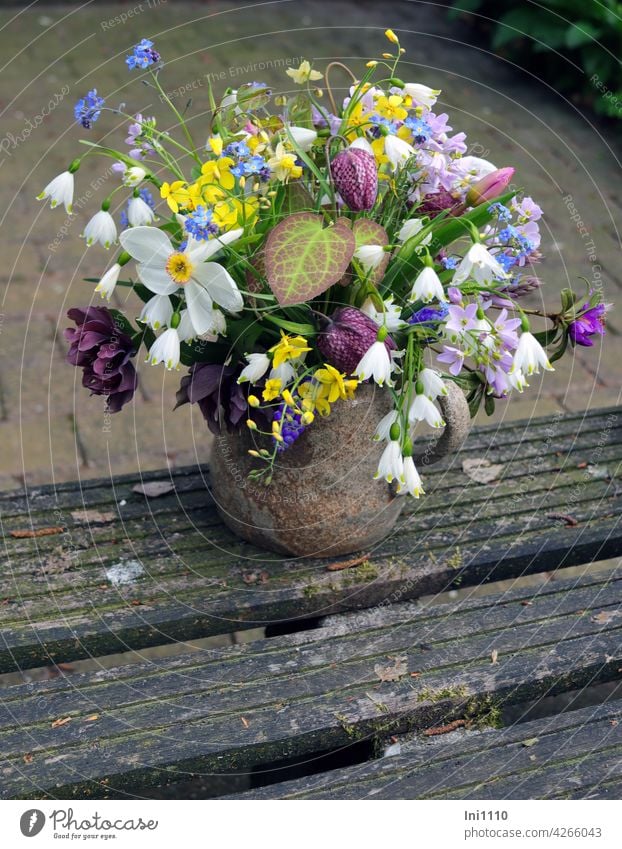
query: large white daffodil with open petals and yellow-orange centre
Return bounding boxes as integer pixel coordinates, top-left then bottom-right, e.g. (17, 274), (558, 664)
(119, 227), (244, 336)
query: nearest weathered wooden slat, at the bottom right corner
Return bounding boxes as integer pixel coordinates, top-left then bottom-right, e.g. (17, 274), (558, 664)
(233, 701), (622, 796)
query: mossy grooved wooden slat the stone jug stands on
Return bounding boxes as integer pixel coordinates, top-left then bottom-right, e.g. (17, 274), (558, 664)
(0, 404), (622, 671)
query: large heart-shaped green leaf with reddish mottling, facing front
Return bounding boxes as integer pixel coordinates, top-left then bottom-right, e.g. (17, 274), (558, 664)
(265, 212), (356, 306)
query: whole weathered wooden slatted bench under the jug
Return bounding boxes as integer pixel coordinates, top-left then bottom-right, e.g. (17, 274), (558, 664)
(0, 409), (622, 798)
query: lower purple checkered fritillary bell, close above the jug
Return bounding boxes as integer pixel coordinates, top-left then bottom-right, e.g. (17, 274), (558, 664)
(317, 307), (397, 374)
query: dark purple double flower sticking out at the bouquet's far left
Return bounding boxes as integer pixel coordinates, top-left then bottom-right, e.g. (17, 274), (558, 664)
(64, 307), (138, 413)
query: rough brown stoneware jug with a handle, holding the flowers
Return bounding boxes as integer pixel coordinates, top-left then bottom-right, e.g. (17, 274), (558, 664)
(210, 382), (470, 557)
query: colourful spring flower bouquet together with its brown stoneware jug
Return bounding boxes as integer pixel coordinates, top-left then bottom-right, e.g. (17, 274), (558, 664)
(40, 30), (608, 553)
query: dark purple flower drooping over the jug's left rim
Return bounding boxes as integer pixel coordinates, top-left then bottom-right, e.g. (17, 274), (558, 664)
(175, 363), (248, 434)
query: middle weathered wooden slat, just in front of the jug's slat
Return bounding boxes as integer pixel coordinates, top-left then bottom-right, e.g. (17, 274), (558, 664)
(0, 570), (622, 798)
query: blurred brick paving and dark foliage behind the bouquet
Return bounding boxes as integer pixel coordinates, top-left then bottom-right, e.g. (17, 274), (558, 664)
(0, 0), (622, 489)
